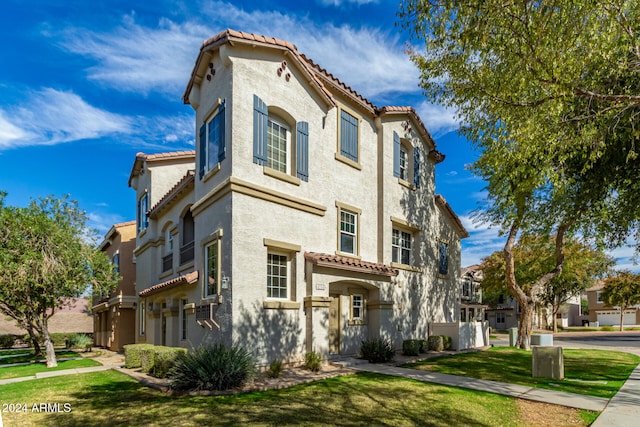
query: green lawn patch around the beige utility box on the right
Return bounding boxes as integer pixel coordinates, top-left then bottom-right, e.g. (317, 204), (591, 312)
(406, 347), (640, 398)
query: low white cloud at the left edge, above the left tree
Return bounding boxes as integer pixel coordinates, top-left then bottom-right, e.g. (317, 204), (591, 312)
(0, 88), (131, 149)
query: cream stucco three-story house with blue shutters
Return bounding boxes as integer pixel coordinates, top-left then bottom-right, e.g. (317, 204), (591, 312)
(129, 30), (468, 363)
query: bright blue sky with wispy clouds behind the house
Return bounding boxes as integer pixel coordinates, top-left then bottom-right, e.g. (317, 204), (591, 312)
(0, 0), (637, 269)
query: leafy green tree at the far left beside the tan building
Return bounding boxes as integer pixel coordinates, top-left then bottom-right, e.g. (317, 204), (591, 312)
(0, 193), (118, 367)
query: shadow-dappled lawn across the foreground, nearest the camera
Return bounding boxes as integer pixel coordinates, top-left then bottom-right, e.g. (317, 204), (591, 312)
(0, 371), (596, 427)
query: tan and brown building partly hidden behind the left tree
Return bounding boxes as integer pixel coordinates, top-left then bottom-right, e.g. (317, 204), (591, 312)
(91, 221), (138, 351)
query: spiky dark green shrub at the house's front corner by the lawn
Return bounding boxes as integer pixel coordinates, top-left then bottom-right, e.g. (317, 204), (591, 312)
(168, 343), (255, 391)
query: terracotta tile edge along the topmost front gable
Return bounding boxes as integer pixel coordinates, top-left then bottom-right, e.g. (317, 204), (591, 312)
(182, 29), (335, 105)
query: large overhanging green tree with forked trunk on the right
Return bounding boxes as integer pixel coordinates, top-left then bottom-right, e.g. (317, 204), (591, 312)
(400, 0), (640, 348)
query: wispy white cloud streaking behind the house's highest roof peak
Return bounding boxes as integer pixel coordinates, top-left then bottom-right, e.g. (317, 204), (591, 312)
(53, 2), (419, 98)
